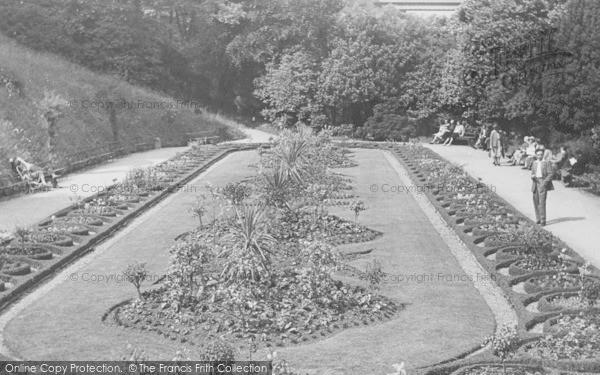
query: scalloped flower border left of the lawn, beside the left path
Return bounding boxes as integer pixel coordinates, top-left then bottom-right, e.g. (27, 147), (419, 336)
(0, 146), (236, 316)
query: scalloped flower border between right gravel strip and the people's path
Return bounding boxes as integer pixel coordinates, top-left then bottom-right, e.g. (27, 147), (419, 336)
(386, 144), (600, 375)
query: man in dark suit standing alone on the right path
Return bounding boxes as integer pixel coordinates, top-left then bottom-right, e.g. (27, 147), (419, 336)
(531, 148), (554, 226)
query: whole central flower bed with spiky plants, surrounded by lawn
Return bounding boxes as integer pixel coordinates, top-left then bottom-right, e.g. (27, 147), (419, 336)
(108, 133), (402, 356)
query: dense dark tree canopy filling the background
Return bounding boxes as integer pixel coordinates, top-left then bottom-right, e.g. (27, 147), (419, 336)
(0, 0), (600, 151)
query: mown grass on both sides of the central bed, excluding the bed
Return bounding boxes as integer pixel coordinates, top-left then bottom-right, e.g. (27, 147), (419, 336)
(0, 150), (508, 374)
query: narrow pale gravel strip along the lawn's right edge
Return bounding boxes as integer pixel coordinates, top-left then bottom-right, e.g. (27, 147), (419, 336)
(383, 151), (518, 330)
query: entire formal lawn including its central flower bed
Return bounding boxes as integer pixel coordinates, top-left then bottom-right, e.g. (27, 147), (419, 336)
(3, 131), (495, 374)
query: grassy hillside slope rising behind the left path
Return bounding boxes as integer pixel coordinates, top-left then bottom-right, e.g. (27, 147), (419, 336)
(0, 35), (244, 172)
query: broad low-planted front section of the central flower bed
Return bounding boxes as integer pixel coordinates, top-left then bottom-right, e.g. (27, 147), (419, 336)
(115, 269), (399, 348)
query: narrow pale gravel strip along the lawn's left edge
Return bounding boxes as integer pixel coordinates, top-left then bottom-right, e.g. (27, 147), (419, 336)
(0, 154), (227, 360)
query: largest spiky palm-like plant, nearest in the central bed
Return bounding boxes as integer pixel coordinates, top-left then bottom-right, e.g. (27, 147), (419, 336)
(219, 205), (277, 281)
